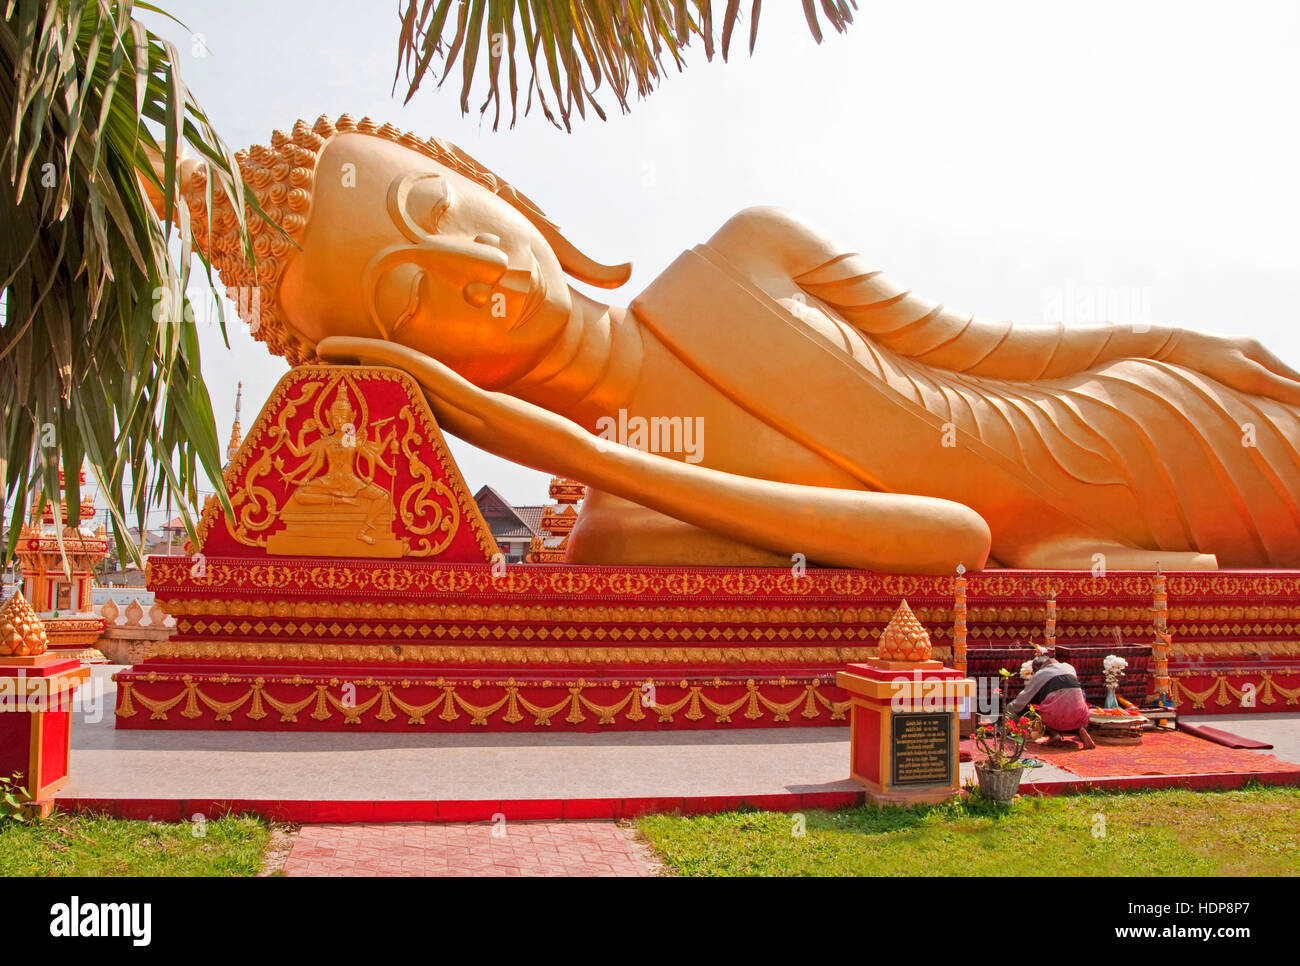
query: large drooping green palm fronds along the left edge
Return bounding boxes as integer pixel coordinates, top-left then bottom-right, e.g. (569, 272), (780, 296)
(0, 0), (247, 559)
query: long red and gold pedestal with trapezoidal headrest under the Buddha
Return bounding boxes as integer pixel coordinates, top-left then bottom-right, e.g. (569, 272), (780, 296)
(109, 365), (1300, 738)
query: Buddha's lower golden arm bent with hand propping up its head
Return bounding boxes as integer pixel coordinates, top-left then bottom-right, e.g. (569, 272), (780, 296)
(317, 337), (989, 573)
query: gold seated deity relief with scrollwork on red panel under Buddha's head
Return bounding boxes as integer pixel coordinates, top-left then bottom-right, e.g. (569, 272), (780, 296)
(228, 369), (460, 558)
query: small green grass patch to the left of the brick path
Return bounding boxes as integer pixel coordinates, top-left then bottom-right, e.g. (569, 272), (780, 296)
(0, 813), (270, 876)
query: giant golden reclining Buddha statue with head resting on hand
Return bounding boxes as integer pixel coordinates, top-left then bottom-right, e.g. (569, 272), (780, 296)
(170, 116), (1300, 573)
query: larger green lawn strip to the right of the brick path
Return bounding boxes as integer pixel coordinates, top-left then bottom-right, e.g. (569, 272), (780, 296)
(638, 788), (1300, 876)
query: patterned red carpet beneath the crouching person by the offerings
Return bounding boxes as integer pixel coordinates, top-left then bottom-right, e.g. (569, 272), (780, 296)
(1026, 732), (1300, 779)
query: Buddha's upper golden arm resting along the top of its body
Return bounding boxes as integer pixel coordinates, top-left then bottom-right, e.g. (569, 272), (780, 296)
(709, 208), (1300, 404)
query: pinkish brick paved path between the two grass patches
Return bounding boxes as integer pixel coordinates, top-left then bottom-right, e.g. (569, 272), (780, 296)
(285, 822), (654, 876)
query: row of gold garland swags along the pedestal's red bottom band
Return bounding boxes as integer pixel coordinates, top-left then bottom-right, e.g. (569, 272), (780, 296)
(114, 672), (850, 728)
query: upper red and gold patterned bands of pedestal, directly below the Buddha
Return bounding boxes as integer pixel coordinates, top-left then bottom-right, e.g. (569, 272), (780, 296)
(148, 555), (1300, 662)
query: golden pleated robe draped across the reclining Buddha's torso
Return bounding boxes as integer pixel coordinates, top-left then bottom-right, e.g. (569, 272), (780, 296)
(632, 246), (1300, 567)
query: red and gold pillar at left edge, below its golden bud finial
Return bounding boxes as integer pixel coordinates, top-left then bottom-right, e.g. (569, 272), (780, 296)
(0, 654), (90, 810)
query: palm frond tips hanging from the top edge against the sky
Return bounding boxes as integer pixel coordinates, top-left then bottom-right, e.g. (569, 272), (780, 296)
(394, 0), (858, 130)
